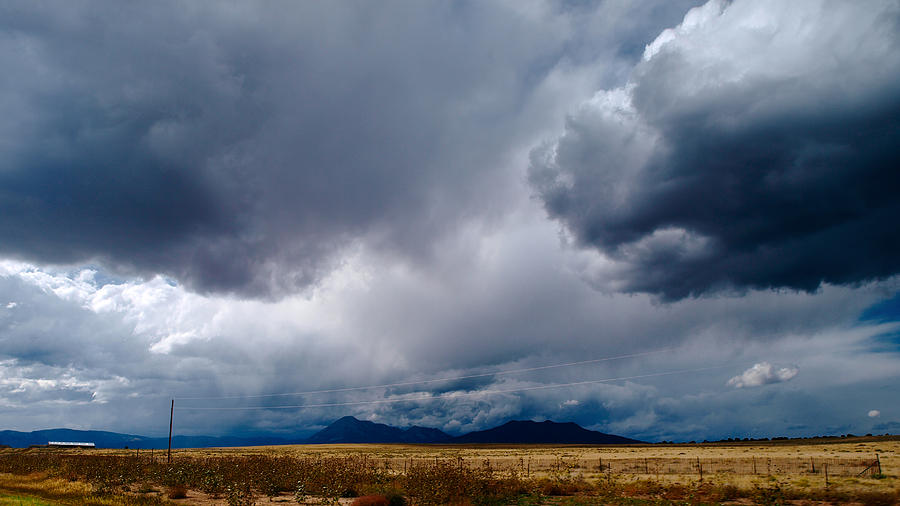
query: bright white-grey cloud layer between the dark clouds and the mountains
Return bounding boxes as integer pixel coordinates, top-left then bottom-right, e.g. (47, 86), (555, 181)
(0, 252), (900, 440)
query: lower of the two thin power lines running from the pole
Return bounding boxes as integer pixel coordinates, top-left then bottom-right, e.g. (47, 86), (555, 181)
(178, 365), (728, 411)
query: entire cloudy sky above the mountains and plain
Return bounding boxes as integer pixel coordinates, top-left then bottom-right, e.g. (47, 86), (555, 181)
(0, 0), (900, 441)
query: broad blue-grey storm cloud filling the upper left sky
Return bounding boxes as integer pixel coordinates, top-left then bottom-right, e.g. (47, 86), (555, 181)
(0, 1), (704, 297)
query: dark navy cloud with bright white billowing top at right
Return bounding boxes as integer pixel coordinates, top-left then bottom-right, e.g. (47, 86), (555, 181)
(530, 1), (900, 300)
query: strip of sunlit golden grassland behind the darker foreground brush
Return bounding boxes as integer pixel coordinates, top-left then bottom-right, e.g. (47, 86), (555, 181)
(112, 436), (900, 483)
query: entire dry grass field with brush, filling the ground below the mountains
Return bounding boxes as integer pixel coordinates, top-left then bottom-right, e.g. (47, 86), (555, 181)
(0, 437), (900, 504)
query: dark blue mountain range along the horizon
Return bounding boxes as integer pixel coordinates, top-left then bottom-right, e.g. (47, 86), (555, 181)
(0, 416), (641, 449)
